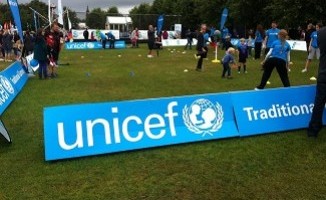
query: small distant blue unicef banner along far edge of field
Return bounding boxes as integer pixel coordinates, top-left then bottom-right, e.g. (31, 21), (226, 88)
(65, 40), (126, 50)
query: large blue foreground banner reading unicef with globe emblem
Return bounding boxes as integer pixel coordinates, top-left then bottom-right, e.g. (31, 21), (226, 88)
(44, 94), (239, 161)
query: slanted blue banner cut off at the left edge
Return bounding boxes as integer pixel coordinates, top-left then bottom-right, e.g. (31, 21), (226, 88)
(0, 62), (28, 115)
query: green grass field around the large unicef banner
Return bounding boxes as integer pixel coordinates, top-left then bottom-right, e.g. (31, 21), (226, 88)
(0, 45), (326, 200)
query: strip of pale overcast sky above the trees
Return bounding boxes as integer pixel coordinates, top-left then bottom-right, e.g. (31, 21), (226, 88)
(17, 0), (154, 14)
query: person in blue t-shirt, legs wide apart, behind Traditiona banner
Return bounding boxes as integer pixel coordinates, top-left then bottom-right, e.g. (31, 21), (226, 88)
(256, 29), (291, 89)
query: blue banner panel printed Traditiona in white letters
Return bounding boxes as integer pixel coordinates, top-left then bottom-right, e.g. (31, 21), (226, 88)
(232, 86), (316, 136)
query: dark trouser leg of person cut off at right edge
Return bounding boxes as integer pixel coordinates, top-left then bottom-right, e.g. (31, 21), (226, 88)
(308, 82), (326, 136)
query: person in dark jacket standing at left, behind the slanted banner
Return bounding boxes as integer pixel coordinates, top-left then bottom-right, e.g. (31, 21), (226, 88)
(34, 28), (48, 79)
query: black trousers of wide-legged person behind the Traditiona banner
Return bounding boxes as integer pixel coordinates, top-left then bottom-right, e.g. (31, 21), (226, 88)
(257, 58), (290, 89)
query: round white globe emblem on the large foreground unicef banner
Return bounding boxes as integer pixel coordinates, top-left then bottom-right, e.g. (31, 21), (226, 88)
(183, 99), (224, 136)
